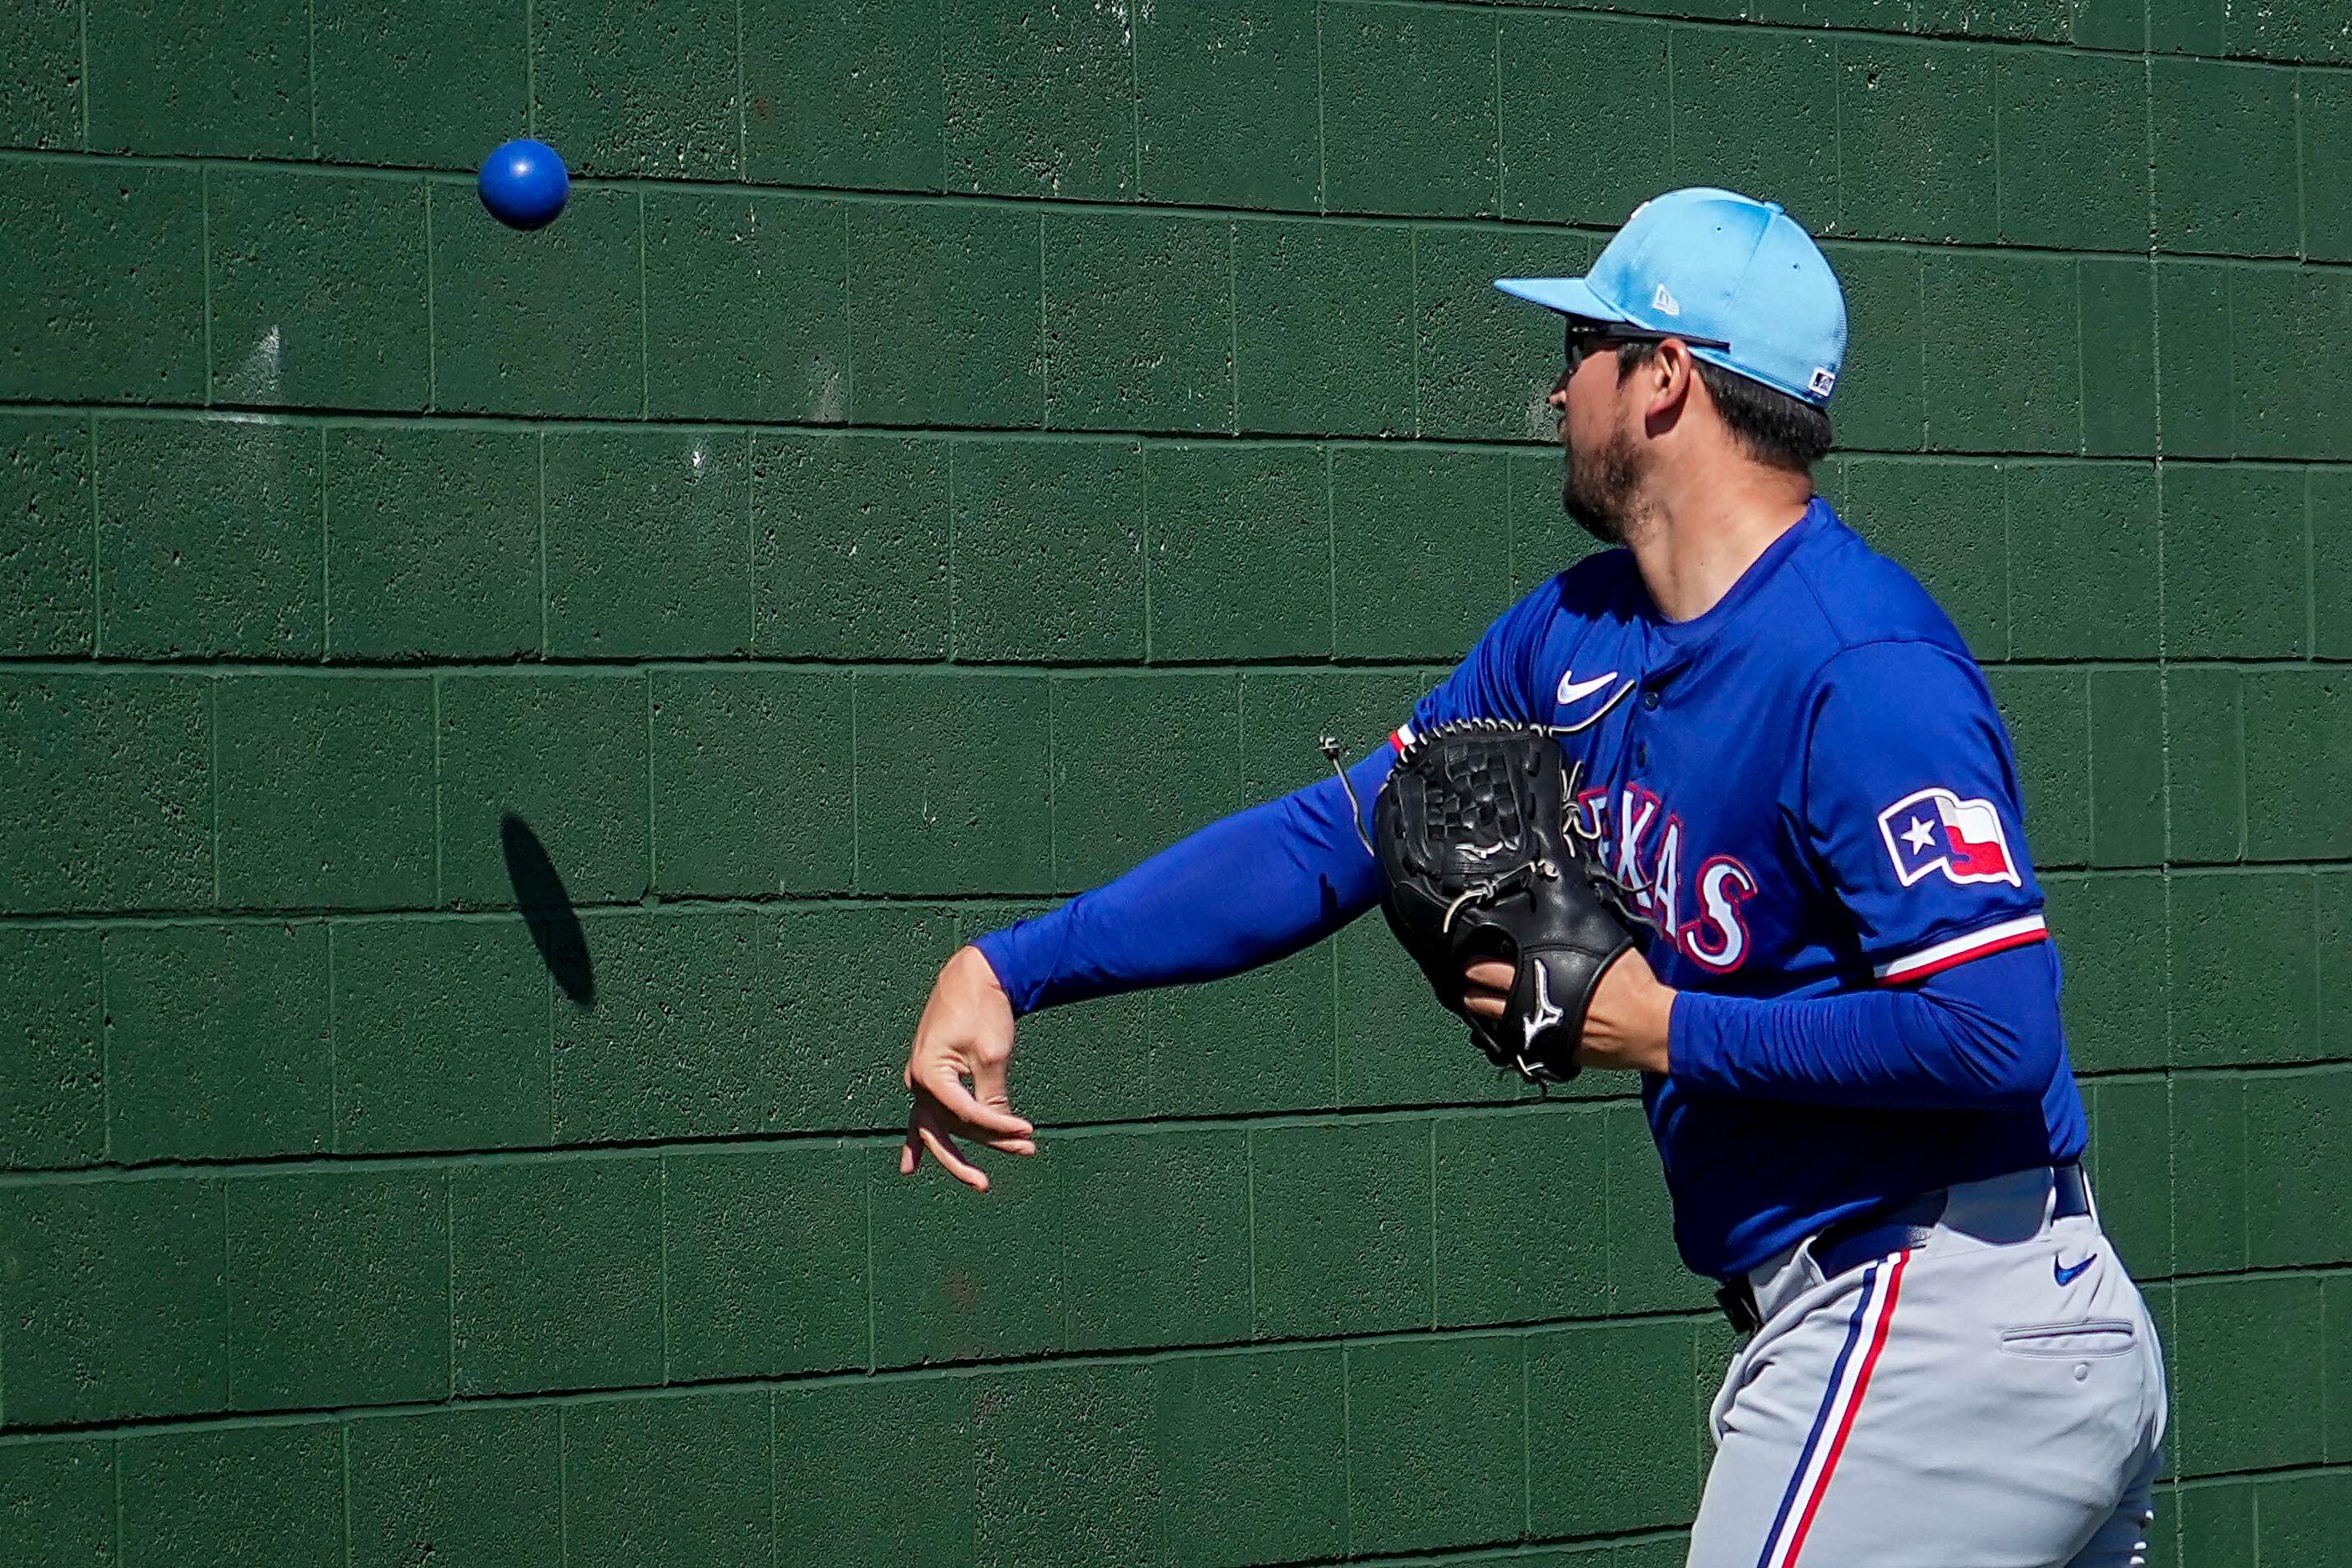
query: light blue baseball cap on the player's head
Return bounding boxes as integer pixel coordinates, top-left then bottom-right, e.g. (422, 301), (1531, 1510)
(1494, 185), (1846, 404)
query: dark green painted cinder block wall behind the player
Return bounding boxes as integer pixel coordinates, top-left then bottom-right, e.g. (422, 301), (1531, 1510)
(0, 0), (2352, 1568)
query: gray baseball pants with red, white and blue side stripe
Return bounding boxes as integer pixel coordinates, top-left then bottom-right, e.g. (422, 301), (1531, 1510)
(1689, 1168), (2166, 1568)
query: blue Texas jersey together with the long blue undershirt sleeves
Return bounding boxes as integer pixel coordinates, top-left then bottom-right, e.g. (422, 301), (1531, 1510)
(976, 501), (2084, 1277)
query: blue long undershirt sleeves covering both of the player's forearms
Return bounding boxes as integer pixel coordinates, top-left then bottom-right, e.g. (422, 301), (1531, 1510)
(976, 746), (2063, 1110)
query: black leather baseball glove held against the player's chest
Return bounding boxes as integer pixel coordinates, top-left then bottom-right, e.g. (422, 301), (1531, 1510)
(1371, 720), (1649, 1084)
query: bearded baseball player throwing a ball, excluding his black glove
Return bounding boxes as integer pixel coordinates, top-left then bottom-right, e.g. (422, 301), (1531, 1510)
(901, 188), (2166, 1568)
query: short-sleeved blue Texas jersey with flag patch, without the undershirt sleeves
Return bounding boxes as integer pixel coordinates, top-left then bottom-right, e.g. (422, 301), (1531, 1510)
(1394, 501), (2084, 1274)
